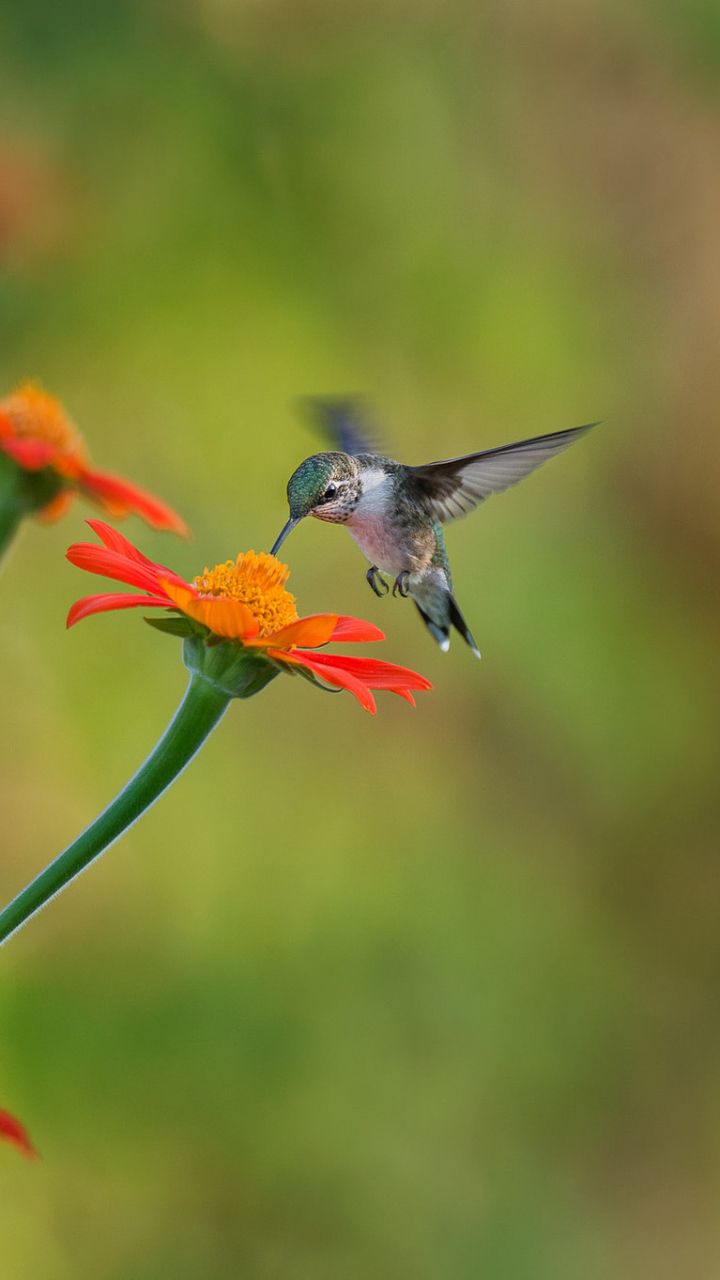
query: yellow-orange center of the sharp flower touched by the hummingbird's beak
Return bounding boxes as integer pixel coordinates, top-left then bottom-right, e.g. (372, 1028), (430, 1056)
(195, 552), (297, 636)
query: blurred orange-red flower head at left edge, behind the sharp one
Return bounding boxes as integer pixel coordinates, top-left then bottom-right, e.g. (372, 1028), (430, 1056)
(0, 383), (187, 535)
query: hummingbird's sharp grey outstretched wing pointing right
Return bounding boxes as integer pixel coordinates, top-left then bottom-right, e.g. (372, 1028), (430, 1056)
(407, 422), (598, 521)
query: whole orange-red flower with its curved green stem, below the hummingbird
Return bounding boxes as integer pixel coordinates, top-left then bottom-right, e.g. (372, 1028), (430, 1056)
(0, 520), (430, 945)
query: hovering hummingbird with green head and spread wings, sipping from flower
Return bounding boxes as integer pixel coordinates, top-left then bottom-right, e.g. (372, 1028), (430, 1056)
(270, 398), (597, 658)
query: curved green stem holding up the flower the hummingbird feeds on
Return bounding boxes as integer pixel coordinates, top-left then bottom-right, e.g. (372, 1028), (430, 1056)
(0, 675), (231, 945)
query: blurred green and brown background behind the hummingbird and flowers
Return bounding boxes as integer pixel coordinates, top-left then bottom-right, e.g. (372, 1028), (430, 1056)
(0, 0), (720, 1280)
